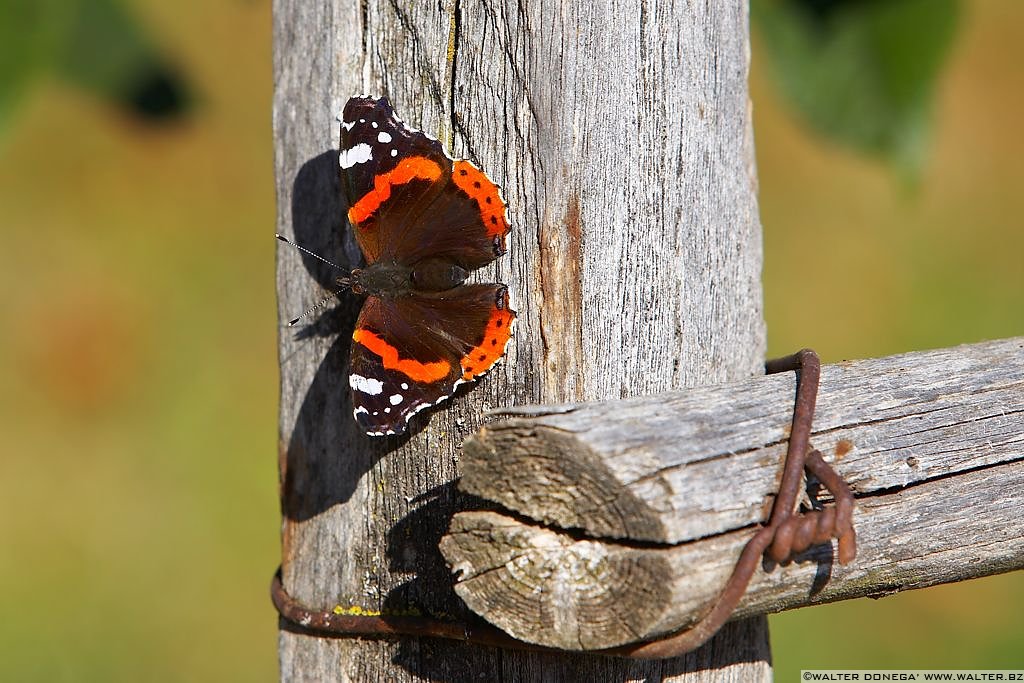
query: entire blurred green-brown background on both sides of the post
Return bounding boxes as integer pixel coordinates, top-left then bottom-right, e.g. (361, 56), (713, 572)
(0, 0), (1024, 681)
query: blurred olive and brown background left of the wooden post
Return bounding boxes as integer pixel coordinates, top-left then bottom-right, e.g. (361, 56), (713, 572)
(0, 0), (281, 683)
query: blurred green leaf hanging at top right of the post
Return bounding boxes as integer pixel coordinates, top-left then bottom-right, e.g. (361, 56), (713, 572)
(752, 0), (959, 180)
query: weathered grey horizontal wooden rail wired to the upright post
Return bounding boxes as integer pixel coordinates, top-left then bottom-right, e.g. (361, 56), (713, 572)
(441, 338), (1024, 649)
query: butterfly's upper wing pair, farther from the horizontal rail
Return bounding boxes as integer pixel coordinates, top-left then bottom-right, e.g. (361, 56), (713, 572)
(339, 97), (509, 270)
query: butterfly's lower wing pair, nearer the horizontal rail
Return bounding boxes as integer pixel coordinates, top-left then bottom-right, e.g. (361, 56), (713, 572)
(349, 285), (515, 436)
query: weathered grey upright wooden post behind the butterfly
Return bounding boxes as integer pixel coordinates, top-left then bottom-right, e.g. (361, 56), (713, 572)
(274, 0), (771, 681)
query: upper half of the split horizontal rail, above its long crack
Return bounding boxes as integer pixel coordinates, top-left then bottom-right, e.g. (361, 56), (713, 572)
(460, 339), (1024, 543)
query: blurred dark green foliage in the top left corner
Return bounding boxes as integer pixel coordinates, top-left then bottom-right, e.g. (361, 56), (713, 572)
(0, 0), (190, 135)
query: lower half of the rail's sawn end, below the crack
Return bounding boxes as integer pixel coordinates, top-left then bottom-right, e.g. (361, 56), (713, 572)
(440, 512), (671, 650)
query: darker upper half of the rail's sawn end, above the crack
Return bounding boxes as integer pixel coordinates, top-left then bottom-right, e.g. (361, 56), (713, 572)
(459, 419), (665, 542)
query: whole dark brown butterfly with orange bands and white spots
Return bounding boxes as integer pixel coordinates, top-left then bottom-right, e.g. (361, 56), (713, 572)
(339, 97), (515, 436)
